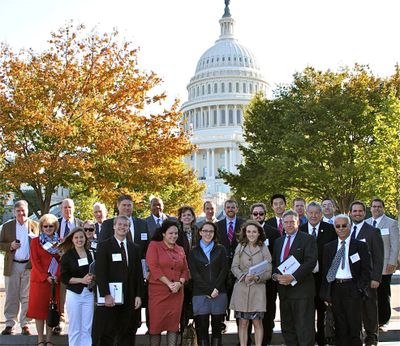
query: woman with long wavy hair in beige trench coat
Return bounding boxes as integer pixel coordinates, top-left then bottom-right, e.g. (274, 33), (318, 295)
(229, 220), (272, 346)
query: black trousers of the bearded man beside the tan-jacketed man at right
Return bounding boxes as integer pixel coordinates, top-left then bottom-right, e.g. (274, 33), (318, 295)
(362, 287), (378, 345)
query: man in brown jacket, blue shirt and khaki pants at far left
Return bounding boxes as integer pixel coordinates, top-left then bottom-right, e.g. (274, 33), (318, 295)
(0, 200), (39, 335)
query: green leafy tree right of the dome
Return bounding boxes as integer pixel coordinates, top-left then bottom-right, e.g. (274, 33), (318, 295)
(224, 65), (400, 211)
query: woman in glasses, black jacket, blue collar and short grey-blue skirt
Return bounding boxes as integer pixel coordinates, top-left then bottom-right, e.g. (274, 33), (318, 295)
(189, 221), (228, 346)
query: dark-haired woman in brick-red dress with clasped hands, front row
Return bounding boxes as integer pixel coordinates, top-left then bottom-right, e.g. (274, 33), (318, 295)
(146, 220), (189, 346)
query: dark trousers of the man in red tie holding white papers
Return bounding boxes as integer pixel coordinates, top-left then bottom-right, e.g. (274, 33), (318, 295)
(280, 297), (315, 346)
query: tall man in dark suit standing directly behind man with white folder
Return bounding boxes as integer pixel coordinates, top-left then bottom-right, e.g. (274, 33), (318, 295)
(98, 195), (150, 258)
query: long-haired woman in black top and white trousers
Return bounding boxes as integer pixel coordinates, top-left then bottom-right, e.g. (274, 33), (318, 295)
(59, 227), (94, 346)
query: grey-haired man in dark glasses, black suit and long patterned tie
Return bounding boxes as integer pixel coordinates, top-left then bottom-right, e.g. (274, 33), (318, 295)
(321, 214), (371, 346)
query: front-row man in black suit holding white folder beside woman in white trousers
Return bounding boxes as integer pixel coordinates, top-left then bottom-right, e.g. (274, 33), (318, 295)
(94, 215), (143, 346)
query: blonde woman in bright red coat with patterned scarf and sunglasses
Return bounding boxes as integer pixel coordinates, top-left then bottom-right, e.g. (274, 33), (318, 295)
(26, 214), (60, 346)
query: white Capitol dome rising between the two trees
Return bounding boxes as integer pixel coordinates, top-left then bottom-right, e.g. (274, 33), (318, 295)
(181, 1), (268, 206)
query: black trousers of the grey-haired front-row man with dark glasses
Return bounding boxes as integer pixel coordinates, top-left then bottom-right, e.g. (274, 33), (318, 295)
(331, 281), (362, 346)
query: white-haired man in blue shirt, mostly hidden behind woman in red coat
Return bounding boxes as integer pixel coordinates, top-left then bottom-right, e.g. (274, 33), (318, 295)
(53, 198), (83, 335)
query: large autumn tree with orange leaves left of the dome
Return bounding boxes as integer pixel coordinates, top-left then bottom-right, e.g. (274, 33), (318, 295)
(0, 24), (203, 213)
